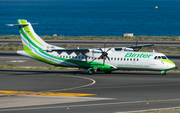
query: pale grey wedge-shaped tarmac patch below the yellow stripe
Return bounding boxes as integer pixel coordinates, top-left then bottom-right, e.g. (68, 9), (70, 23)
(0, 95), (113, 111)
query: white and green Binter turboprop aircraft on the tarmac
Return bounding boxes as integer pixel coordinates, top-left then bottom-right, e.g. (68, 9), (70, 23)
(7, 19), (175, 75)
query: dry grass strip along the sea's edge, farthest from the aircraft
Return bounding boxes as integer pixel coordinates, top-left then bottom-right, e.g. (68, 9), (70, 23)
(0, 35), (180, 41)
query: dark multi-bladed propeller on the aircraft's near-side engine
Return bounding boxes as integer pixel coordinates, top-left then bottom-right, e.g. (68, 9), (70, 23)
(98, 40), (112, 67)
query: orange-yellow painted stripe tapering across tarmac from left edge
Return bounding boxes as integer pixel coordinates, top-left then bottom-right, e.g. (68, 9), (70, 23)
(0, 90), (96, 97)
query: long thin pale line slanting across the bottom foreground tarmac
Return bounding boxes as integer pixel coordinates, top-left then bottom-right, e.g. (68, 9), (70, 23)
(0, 99), (180, 111)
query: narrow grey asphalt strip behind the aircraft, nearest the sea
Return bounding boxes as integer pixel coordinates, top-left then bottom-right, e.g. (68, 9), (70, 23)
(0, 39), (180, 46)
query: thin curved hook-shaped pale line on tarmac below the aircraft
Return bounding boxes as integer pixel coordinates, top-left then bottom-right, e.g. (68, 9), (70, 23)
(48, 75), (96, 91)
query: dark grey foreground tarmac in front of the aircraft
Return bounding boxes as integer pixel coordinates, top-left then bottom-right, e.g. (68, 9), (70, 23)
(0, 70), (180, 113)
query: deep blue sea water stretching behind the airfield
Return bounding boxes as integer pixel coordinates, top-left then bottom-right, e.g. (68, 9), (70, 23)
(0, 0), (180, 36)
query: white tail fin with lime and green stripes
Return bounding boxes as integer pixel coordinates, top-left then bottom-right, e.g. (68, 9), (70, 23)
(17, 19), (50, 50)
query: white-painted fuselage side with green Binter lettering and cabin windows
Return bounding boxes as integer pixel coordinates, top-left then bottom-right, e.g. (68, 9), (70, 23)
(45, 51), (175, 70)
